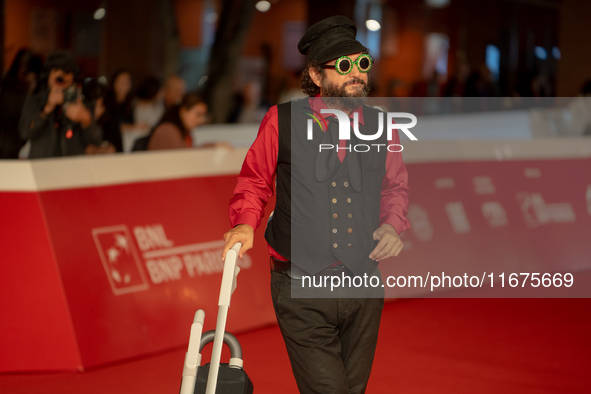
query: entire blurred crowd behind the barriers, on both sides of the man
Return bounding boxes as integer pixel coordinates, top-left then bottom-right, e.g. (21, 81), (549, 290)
(0, 49), (591, 159)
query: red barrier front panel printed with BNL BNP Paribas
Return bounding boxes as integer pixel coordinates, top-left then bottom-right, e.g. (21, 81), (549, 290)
(41, 176), (275, 367)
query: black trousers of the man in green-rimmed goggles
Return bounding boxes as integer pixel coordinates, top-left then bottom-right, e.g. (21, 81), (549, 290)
(271, 271), (384, 394)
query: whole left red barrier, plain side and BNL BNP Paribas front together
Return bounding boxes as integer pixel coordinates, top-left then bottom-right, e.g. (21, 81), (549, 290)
(0, 154), (275, 371)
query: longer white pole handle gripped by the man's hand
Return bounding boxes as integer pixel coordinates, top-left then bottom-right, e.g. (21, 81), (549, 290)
(205, 242), (242, 394)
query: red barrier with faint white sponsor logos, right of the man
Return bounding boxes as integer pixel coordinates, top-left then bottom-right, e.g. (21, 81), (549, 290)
(380, 159), (591, 297)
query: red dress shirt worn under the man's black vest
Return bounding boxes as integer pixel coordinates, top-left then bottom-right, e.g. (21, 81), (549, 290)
(229, 99), (410, 260)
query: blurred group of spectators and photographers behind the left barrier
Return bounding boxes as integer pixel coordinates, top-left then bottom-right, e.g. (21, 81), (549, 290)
(0, 49), (220, 159)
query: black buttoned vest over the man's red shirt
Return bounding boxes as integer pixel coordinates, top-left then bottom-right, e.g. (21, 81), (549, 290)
(265, 98), (388, 275)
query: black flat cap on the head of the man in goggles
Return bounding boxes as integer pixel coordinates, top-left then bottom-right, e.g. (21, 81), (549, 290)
(298, 15), (367, 64)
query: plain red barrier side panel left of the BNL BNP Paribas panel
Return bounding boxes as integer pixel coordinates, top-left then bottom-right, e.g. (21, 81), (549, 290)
(0, 192), (81, 371)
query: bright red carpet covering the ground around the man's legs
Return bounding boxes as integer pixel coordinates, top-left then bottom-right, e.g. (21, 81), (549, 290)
(0, 299), (591, 394)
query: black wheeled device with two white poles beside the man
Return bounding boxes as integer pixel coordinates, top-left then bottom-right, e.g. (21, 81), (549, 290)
(180, 243), (253, 394)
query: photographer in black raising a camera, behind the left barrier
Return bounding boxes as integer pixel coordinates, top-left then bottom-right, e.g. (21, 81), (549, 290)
(19, 51), (102, 159)
